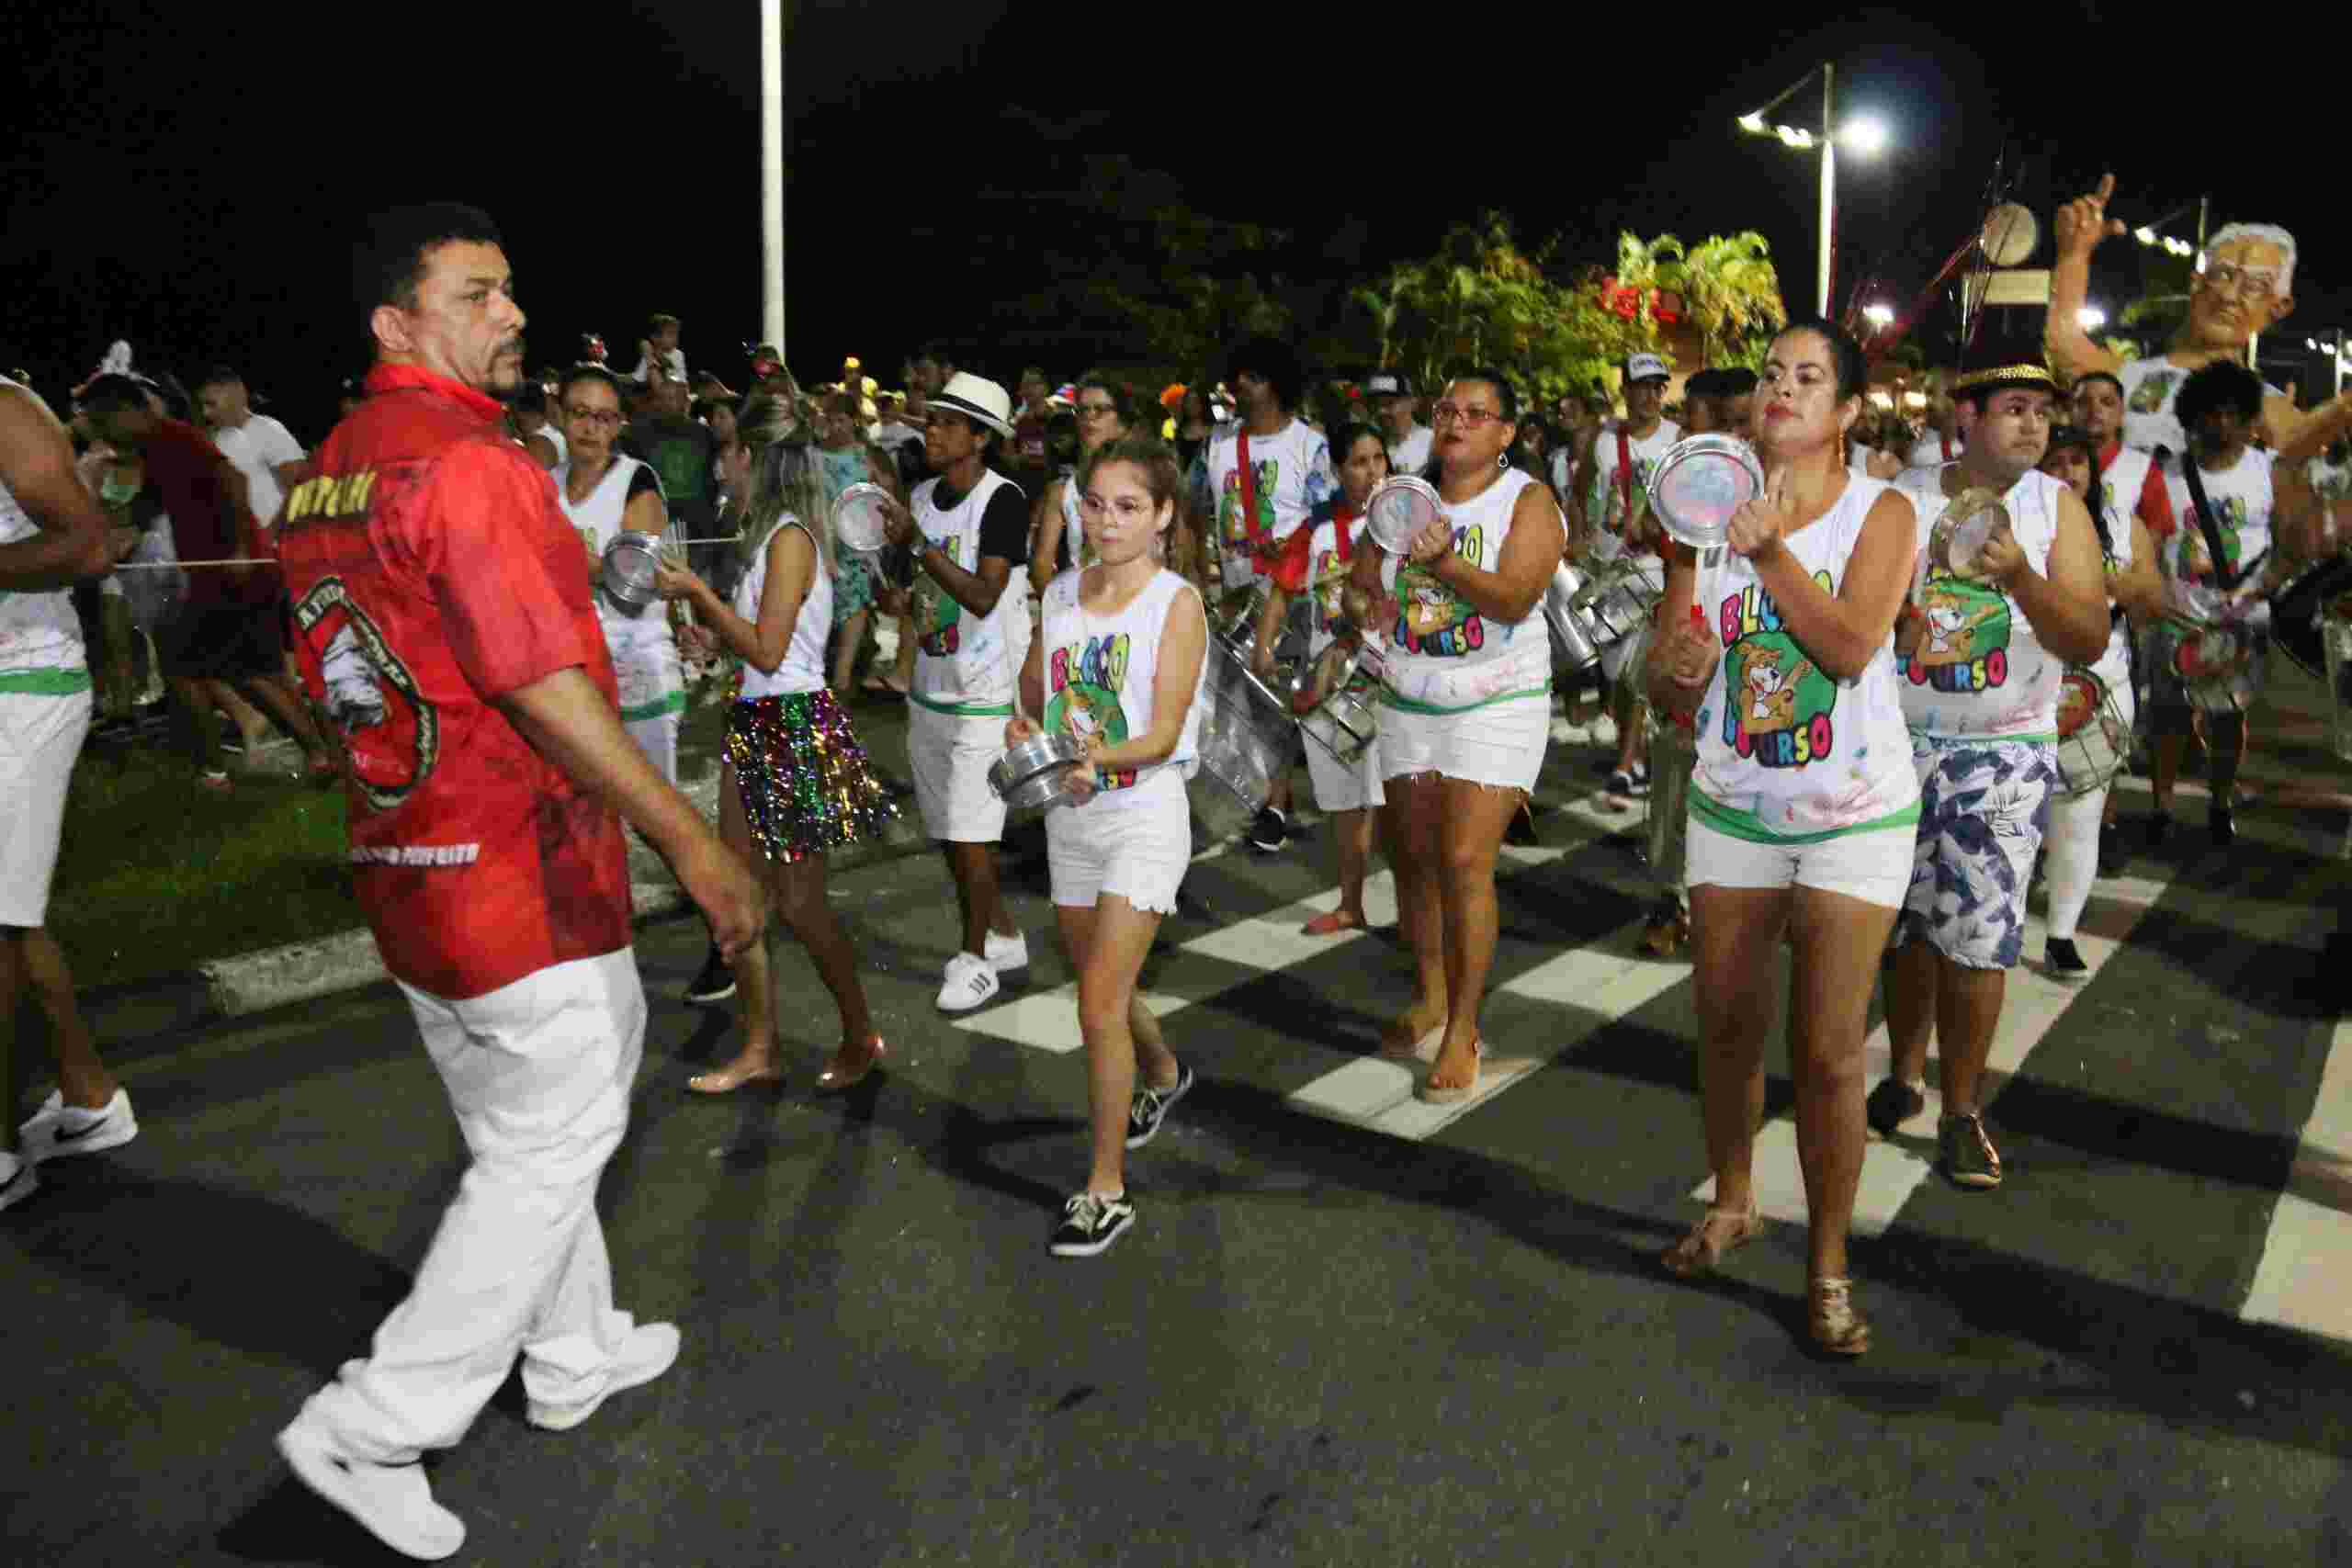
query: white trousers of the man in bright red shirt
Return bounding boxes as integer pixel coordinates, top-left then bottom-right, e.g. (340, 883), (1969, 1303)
(308, 947), (644, 1464)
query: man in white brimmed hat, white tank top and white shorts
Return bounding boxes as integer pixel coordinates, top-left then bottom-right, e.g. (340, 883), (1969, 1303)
(875, 374), (1028, 1013)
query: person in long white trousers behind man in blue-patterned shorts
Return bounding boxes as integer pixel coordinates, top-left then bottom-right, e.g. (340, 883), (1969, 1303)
(2041, 425), (2164, 980)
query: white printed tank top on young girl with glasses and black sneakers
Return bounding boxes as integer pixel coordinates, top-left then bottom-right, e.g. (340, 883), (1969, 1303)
(1040, 567), (1209, 813)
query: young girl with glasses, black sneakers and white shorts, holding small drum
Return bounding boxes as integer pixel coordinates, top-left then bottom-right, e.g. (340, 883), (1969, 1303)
(1004, 434), (1209, 1258)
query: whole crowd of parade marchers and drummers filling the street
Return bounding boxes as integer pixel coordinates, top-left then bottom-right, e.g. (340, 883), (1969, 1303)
(0, 186), (2352, 1559)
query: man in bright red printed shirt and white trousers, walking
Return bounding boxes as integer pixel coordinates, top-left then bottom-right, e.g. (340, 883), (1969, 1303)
(277, 205), (764, 1559)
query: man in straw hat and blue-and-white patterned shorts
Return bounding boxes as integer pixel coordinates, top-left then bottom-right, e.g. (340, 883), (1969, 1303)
(1868, 365), (2108, 1187)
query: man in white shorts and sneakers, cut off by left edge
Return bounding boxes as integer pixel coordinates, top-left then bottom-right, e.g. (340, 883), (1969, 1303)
(0, 378), (139, 1208)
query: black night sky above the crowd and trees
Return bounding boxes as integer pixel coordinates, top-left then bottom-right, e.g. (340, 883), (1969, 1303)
(14, 0), (2352, 440)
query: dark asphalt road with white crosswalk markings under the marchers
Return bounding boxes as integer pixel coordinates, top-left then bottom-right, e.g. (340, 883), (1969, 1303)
(0, 677), (2352, 1565)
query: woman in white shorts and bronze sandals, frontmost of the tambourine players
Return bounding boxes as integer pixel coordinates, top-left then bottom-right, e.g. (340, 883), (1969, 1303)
(1649, 320), (1919, 1357)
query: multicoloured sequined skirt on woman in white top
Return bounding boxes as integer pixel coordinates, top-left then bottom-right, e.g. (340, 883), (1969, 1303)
(727, 691), (899, 865)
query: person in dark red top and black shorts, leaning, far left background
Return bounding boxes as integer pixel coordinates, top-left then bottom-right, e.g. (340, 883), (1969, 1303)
(75, 376), (332, 790)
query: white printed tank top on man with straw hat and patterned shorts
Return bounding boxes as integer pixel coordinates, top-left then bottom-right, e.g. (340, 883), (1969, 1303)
(1895, 468), (2065, 740)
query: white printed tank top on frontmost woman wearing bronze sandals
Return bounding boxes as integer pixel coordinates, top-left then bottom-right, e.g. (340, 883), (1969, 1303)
(1691, 475), (1919, 841)
